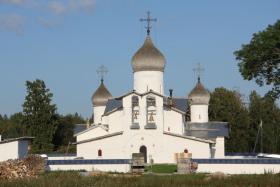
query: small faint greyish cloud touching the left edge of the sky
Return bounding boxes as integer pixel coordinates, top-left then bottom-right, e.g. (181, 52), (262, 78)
(0, 14), (25, 35)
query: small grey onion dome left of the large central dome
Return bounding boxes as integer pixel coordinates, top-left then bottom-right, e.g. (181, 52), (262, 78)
(91, 80), (112, 106)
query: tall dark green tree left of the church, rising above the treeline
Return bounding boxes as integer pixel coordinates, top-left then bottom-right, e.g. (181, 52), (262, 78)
(23, 79), (58, 153)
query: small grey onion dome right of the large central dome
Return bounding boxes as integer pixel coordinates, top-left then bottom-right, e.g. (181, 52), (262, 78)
(188, 78), (210, 105)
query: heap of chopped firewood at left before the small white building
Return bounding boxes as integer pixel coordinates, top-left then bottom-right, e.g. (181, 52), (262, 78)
(0, 155), (45, 179)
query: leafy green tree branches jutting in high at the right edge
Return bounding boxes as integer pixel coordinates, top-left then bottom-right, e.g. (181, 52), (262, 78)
(234, 20), (280, 98)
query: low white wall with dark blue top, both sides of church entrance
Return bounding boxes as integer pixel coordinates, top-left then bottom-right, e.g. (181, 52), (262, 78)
(47, 158), (280, 174)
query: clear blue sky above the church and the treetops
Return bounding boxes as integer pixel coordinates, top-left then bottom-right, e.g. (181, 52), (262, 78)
(0, 0), (280, 117)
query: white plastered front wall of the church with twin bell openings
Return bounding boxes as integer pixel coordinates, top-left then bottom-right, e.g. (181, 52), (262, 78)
(77, 93), (210, 163)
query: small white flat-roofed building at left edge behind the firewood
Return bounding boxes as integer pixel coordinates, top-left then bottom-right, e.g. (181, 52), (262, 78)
(0, 136), (33, 162)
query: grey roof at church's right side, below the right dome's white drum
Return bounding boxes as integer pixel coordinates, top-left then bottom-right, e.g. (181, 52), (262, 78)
(185, 122), (229, 139)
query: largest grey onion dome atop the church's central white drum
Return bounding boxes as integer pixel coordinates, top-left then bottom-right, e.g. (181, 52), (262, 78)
(131, 36), (166, 72)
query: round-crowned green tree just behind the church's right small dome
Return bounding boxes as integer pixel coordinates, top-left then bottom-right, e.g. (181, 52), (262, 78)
(209, 88), (250, 152)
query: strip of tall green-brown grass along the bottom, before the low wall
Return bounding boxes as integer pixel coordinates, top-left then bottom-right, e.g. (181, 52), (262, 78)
(0, 172), (280, 187)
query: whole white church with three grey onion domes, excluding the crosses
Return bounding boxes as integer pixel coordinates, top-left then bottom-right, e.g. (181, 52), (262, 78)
(75, 29), (228, 163)
